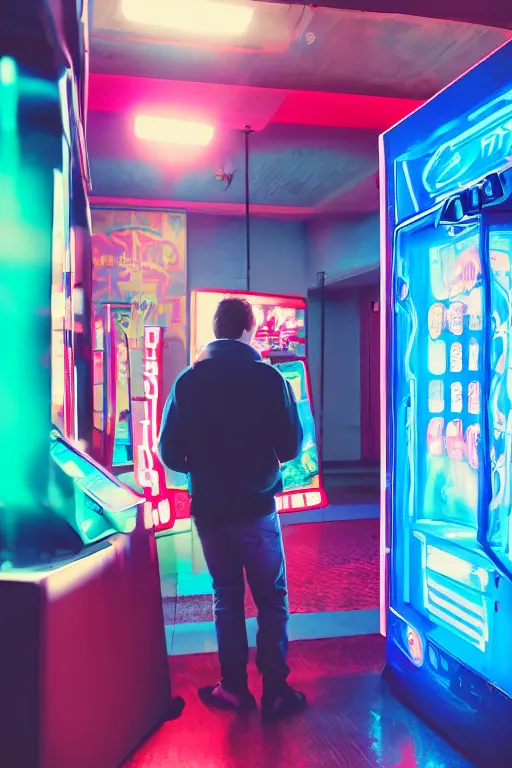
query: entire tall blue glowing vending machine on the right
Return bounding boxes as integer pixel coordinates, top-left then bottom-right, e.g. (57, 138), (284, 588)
(380, 43), (512, 768)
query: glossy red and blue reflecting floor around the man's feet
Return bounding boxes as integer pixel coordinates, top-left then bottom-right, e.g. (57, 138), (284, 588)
(130, 500), (470, 768)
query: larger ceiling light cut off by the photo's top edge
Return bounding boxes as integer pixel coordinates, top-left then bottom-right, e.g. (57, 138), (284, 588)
(123, 0), (254, 37)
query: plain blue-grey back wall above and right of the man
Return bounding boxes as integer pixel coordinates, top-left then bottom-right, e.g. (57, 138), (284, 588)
(89, 207), (379, 468)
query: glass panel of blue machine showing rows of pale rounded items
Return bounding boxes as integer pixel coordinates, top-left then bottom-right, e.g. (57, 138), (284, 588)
(396, 222), (482, 529)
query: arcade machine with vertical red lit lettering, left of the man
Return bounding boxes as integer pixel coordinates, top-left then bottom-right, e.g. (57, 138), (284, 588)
(92, 295), (188, 533)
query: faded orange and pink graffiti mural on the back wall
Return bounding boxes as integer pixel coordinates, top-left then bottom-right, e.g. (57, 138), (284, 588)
(92, 209), (187, 392)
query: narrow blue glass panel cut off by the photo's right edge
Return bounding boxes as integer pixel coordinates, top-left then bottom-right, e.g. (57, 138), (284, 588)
(489, 225), (512, 568)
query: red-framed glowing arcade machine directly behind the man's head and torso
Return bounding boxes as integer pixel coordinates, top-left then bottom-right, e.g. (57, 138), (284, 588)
(190, 290), (327, 512)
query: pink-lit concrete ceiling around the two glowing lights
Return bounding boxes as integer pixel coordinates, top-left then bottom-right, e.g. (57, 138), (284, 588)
(88, 0), (512, 218)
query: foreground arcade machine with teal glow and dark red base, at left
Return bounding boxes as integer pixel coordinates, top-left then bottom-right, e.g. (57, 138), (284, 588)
(0, 2), (179, 768)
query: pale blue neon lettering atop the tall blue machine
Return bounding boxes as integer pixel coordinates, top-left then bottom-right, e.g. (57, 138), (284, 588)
(423, 91), (512, 196)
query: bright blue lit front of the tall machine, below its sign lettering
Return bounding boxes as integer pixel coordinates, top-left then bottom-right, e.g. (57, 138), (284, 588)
(389, 208), (512, 694)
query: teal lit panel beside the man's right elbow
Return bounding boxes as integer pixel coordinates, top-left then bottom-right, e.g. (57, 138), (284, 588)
(276, 360), (320, 491)
